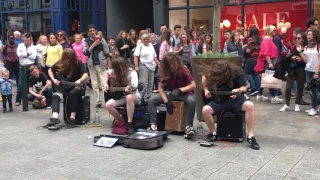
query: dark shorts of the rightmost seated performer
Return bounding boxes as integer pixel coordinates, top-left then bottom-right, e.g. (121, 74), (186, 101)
(207, 97), (247, 114)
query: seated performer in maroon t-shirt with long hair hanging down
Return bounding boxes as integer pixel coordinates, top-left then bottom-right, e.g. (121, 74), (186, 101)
(148, 53), (196, 138)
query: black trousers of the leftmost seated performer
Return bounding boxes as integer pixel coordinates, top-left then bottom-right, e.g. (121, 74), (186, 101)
(51, 88), (85, 113)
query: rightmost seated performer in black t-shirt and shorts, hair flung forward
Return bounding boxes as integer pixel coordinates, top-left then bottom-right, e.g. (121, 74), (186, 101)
(202, 61), (260, 150)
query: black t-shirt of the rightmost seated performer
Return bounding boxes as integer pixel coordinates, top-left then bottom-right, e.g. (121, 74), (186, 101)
(212, 74), (247, 103)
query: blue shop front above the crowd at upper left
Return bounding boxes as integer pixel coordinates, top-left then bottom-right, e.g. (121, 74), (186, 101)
(0, 0), (101, 41)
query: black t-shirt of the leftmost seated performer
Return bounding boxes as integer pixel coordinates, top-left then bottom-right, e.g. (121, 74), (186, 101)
(51, 62), (87, 82)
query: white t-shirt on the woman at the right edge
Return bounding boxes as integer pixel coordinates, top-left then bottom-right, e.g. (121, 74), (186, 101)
(303, 46), (320, 72)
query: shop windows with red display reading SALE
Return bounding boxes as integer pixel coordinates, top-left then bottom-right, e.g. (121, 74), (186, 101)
(156, 0), (320, 47)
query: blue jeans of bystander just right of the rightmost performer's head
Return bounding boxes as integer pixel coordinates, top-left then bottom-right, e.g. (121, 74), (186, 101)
(244, 60), (261, 90)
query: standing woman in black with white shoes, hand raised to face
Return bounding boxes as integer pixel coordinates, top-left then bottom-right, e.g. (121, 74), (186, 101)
(280, 32), (308, 112)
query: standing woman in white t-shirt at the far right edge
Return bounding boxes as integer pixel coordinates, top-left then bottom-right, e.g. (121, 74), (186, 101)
(297, 30), (320, 116)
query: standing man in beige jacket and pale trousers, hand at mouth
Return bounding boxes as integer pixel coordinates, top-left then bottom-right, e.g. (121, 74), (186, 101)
(83, 24), (110, 108)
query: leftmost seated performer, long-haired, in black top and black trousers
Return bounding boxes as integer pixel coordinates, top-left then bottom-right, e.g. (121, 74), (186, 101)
(47, 48), (88, 128)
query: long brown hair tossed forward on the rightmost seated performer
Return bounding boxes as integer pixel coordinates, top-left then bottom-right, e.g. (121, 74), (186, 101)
(204, 60), (242, 90)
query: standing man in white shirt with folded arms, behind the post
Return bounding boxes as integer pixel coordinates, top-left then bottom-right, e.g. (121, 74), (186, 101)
(15, 33), (37, 106)
